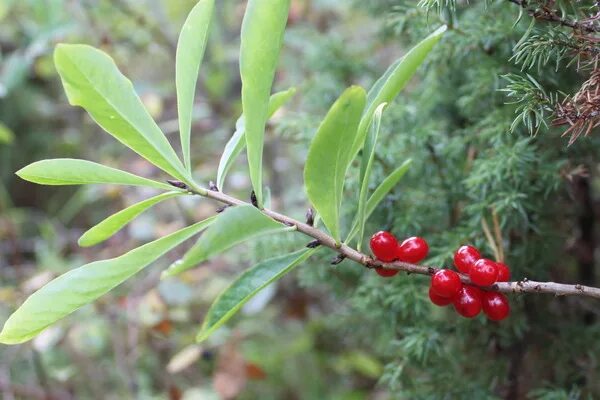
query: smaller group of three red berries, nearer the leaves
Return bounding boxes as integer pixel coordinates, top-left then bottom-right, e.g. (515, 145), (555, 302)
(370, 231), (429, 278)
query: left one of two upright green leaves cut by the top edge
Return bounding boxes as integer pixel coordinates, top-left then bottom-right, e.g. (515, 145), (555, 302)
(175, 0), (215, 172)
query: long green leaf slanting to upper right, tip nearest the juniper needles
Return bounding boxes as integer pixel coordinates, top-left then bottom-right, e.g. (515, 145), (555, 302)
(352, 25), (447, 155)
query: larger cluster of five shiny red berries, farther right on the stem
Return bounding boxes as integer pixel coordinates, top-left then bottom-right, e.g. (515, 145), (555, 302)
(429, 246), (510, 321)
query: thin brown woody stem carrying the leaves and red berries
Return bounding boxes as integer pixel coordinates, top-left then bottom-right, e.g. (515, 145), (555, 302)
(183, 188), (600, 299)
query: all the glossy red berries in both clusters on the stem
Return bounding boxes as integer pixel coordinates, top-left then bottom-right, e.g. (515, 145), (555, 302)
(370, 231), (510, 321)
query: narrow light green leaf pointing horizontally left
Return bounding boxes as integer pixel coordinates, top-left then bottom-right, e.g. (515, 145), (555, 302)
(16, 158), (173, 190)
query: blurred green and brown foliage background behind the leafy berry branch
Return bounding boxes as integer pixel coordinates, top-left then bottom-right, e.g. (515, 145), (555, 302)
(0, 0), (600, 400)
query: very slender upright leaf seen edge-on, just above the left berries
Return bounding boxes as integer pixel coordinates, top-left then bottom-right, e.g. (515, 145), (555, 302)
(356, 103), (387, 251)
